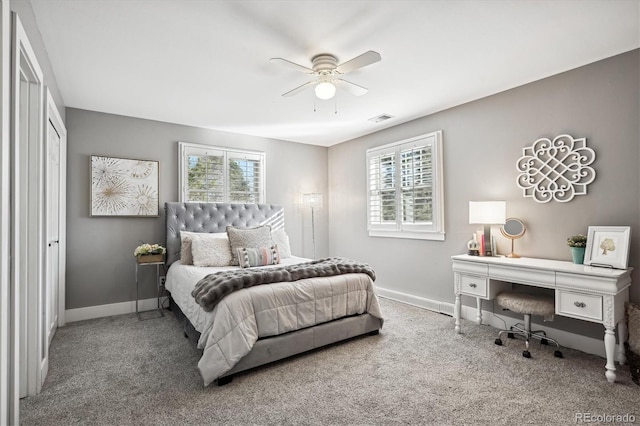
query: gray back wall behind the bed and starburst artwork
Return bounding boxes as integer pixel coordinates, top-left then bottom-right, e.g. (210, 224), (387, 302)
(66, 108), (328, 309)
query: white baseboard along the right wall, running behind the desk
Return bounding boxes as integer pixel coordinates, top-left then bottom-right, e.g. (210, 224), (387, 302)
(376, 287), (618, 360)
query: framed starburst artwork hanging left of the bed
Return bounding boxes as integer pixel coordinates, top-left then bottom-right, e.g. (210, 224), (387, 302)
(90, 155), (160, 217)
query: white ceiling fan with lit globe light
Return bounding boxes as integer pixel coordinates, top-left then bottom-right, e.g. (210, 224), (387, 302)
(269, 50), (382, 99)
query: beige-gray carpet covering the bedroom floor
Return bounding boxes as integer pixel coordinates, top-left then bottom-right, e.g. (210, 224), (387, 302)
(20, 299), (640, 425)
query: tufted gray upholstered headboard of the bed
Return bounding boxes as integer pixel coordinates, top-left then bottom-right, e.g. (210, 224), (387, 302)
(164, 202), (284, 266)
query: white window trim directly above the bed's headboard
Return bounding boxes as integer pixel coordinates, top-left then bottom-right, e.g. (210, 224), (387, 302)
(178, 142), (267, 203)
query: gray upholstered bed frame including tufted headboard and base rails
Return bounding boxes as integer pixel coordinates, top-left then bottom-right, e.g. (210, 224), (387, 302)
(165, 202), (382, 386)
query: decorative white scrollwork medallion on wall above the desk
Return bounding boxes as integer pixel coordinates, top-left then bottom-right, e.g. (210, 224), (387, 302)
(516, 135), (596, 203)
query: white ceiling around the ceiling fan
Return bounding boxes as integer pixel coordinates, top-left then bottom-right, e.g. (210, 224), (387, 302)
(31, 0), (640, 146)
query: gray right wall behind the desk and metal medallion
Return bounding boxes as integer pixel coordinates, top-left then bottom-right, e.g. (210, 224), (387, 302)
(329, 50), (640, 337)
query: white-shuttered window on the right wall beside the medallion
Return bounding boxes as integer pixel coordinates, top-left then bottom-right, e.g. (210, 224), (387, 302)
(367, 131), (444, 241)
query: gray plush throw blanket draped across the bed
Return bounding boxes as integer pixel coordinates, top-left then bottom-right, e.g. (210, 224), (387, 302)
(191, 257), (376, 312)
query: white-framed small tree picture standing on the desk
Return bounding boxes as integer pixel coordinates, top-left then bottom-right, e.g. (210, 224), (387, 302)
(584, 226), (631, 269)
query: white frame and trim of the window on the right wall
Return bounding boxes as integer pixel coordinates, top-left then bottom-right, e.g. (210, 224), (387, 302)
(366, 130), (445, 241)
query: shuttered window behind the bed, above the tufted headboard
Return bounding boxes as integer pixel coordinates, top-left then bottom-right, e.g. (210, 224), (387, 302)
(178, 142), (265, 203)
